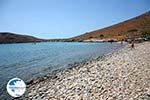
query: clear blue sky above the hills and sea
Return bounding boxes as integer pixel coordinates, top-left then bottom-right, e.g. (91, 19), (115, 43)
(0, 0), (150, 39)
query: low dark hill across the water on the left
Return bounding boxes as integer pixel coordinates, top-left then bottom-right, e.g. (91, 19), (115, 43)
(0, 32), (42, 43)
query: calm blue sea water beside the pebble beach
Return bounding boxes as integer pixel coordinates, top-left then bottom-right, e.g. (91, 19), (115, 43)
(0, 42), (124, 98)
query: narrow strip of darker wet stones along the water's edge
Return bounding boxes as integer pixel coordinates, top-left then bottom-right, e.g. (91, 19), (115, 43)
(26, 42), (123, 85)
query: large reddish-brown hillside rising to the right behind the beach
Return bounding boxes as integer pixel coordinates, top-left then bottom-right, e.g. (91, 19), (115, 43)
(70, 12), (150, 41)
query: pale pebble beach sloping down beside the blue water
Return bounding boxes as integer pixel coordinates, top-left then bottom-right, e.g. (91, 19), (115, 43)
(23, 42), (150, 100)
